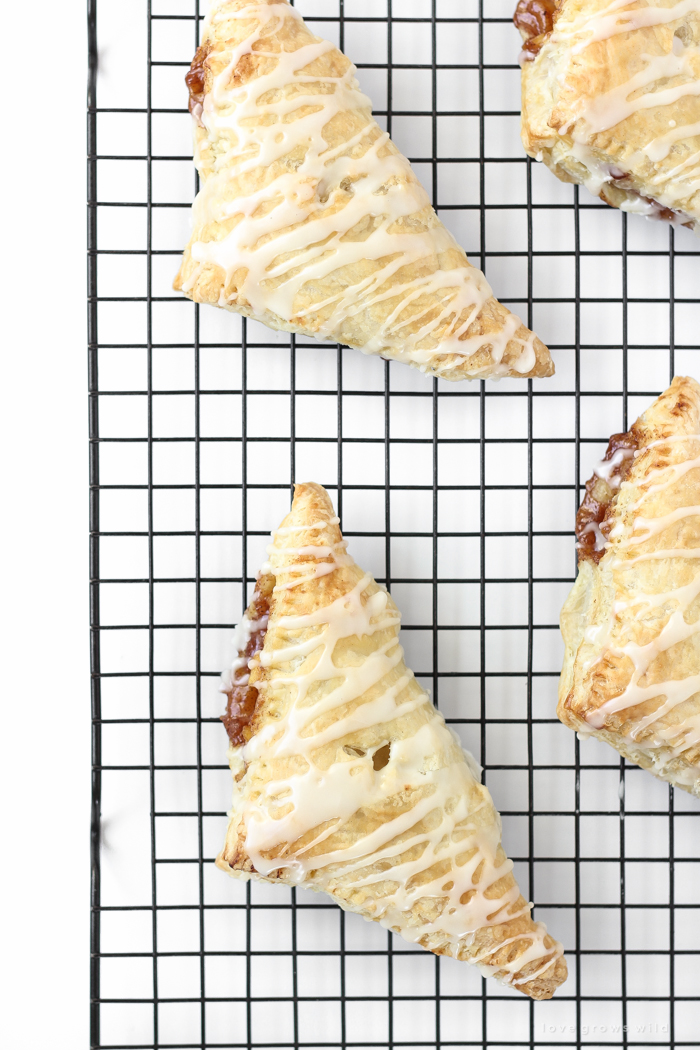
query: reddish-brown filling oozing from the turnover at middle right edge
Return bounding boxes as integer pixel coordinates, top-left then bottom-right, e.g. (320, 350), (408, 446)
(576, 431), (638, 565)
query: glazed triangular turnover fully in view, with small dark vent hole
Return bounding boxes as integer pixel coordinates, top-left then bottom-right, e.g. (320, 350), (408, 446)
(216, 484), (567, 999)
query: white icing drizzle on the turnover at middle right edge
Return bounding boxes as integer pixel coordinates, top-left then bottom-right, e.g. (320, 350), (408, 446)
(585, 434), (700, 794)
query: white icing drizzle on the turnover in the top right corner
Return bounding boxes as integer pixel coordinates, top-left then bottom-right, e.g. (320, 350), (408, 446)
(546, 0), (700, 224)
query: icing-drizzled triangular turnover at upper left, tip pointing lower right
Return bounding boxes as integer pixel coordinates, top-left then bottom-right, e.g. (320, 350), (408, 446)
(174, 0), (554, 379)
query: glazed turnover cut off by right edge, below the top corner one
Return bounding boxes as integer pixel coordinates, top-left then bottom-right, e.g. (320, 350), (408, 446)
(557, 376), (700, 797)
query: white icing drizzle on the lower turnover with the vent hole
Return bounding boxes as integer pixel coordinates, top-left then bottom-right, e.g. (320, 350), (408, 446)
(225, 514), (563, 985)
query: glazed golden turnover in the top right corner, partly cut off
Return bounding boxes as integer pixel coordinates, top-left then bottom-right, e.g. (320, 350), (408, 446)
(515, 0), (700, 233)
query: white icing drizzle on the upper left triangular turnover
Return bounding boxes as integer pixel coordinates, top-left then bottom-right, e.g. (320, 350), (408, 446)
(183, 0), (536, 376)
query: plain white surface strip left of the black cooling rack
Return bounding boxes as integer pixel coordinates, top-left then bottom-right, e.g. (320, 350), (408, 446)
(0, 0), (90, 1050)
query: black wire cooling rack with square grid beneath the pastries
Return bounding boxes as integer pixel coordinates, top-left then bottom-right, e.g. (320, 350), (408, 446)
(88, 0), (700, 1050)
